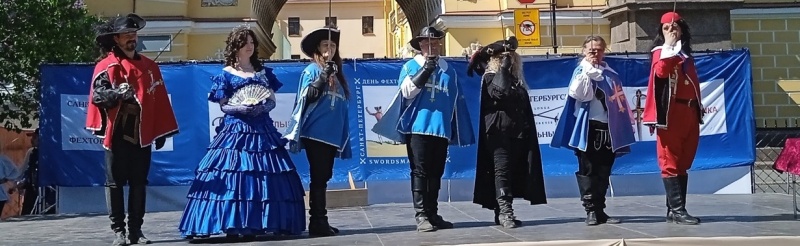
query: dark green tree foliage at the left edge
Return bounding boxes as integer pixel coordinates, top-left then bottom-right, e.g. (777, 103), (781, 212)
(0, 0), (102, 132)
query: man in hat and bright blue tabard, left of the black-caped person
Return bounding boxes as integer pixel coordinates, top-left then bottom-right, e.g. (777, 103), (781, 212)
(372, 27), (475, 232)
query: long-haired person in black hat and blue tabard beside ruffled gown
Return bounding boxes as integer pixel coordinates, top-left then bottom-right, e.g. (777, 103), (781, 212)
(286, 24), (351, 237)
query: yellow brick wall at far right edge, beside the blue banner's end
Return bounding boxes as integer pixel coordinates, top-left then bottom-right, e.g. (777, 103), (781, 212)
(731, 7), (800, 127)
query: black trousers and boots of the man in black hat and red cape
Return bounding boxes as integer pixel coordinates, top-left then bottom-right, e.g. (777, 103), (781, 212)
(105, 134), (152, 232)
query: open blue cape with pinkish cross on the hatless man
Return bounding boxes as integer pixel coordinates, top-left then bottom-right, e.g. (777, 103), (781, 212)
(550, 62), (636, 157)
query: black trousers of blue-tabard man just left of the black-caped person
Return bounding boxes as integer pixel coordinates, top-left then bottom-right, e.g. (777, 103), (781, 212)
(406, 134), (449, 217)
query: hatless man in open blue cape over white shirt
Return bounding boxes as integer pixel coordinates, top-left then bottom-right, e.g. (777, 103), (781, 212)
(550, 36), (636, 225)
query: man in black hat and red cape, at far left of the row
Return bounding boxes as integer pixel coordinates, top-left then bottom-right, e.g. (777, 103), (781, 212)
(86, 14), (178, 245)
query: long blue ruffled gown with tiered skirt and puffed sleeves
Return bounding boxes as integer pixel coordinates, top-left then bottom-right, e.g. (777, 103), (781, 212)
(179, 68), (306, 237)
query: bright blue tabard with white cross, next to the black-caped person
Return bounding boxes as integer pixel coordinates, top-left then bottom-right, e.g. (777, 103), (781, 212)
(372, 55), (475, 146)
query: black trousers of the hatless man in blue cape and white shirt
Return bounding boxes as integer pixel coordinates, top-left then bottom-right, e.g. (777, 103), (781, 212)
(575, 121), (616, 211)
